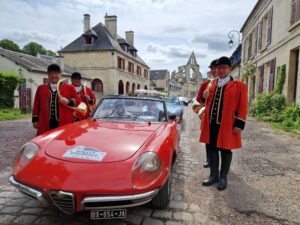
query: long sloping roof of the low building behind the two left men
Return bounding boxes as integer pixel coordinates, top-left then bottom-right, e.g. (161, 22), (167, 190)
(0, 47), (91, 79)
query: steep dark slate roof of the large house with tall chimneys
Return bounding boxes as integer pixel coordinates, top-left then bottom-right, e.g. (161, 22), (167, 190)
(59, 23), (149, 68)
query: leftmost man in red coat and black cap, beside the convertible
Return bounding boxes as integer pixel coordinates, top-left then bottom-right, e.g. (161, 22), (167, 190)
(32, 64), (80, 135)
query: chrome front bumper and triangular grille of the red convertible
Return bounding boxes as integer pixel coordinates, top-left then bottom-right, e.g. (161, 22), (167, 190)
(8, 176), (159, 214)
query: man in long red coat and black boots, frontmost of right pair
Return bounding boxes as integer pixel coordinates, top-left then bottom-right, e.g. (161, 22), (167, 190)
(200, 57), (248, 190)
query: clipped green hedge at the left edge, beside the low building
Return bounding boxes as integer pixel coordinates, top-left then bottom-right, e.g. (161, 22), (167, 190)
(0, 71), (21, 108)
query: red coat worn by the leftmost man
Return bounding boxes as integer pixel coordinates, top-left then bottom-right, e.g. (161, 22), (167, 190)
(32, 84), (80, 135)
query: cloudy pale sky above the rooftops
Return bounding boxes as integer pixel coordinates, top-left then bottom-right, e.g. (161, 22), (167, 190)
(0, 0), (257, 76)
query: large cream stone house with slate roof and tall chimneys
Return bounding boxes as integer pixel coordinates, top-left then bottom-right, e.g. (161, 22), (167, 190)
(60, 14), (149, 98)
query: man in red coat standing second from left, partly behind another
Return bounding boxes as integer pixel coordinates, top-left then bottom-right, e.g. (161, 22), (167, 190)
(71, 72), (96, 121)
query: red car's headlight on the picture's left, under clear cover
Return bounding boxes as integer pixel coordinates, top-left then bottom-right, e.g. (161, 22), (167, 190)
(13, 142), (40, 175)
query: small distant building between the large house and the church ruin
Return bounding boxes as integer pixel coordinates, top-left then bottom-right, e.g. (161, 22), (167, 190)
(149, 70), (170, 93)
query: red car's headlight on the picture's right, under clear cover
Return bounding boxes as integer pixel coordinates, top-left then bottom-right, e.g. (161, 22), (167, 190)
(131, 152), (162, 189)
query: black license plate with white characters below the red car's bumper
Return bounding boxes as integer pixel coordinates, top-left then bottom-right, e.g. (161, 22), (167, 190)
(91, 209), (127, 220)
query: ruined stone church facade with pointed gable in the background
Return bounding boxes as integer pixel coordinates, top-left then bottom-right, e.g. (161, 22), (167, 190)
(171, 52), (202, 97)
